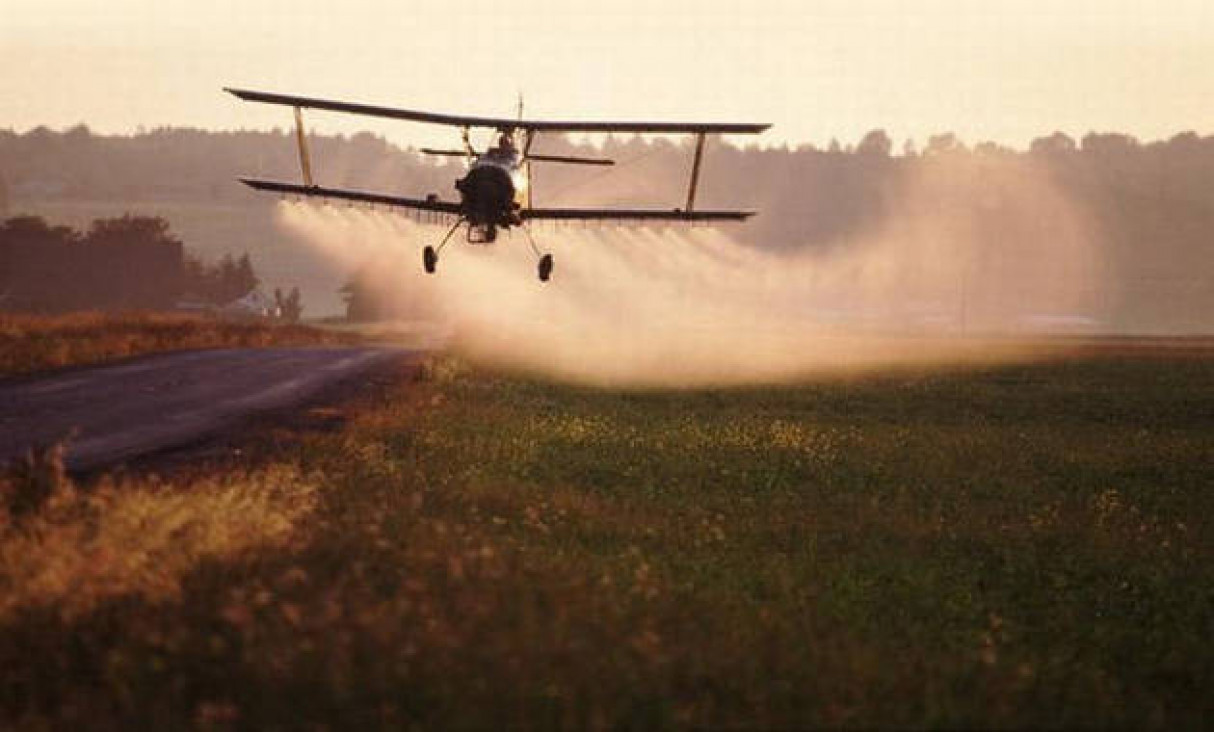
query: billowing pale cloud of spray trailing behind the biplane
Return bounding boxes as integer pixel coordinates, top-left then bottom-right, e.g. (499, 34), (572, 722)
(280, 156), (1102, 386)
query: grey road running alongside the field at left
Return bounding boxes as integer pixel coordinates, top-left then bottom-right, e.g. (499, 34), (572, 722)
(0, 348), (403, 470)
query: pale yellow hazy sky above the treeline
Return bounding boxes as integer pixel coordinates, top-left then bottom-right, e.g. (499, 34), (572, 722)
(7, 0), (1214, 147)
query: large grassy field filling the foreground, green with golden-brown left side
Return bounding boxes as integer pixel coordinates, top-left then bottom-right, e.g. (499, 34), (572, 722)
(0, 350), (1214, 727)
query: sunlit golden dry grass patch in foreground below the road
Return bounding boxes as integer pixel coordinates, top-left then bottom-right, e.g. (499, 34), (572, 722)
(0, 448), (316, 625)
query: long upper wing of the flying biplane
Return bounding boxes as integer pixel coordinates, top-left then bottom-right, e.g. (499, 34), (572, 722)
(225, 89), (771, 135)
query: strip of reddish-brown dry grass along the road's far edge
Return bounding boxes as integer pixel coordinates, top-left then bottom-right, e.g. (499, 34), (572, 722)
(0, 312), (357, 376)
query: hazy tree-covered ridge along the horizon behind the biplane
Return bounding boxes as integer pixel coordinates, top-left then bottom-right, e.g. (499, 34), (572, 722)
(0, 126), (1214, 327)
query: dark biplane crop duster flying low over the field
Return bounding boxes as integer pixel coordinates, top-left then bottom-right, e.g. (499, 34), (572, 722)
(226, 89), (771, 282)
